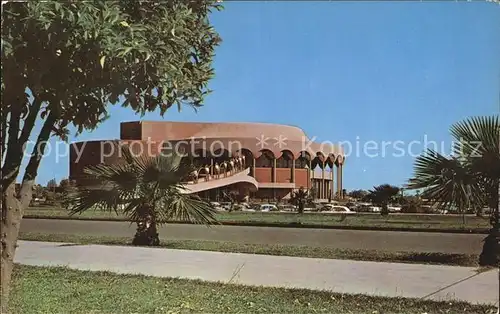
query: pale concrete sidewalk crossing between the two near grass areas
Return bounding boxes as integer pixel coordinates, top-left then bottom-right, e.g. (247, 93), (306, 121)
(15, 241), (499, 304)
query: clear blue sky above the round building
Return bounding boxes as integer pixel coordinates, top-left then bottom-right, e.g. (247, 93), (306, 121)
(23, 1), (500, 190)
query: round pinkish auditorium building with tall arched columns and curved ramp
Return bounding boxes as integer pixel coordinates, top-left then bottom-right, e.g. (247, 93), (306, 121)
(70, 121), (345, 200)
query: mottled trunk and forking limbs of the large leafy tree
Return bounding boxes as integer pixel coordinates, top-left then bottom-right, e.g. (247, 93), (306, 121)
(0, 83), (53, 313)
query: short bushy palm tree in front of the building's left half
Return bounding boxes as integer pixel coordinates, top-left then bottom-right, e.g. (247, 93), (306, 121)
(69, 147), (216, 246)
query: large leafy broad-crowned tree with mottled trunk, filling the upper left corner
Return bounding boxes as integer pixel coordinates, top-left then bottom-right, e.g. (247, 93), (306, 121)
(0, 0), (220, 311)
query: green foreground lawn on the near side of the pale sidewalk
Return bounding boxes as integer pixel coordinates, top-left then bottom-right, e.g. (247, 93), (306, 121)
(10, 265), (494, 314)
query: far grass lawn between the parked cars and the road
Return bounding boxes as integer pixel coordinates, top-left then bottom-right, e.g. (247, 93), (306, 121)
(24, 207), (489, 231)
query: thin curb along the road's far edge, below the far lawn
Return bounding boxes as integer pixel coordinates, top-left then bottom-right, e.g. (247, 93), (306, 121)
(23, 215), (489, 234)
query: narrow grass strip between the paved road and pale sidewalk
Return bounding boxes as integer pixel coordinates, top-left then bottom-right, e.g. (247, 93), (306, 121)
(19, 233), (478, 267)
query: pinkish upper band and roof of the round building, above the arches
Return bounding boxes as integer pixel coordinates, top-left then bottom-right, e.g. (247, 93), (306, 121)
(121, 121), (344, 163)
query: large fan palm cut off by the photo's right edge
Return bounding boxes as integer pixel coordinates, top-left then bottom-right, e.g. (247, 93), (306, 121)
(408, 115), (500, 265)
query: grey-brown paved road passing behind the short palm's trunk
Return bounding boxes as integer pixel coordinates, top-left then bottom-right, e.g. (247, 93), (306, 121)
(21, 219), (484, 254)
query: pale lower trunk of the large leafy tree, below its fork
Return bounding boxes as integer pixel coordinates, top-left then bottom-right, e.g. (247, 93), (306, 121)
(0, 181), (23, 313)
